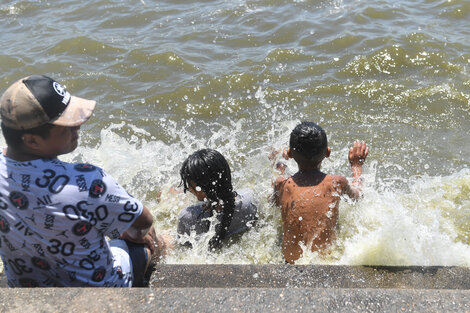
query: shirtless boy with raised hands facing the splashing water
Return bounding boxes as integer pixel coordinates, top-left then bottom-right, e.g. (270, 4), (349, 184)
(274, 122), (369, 264)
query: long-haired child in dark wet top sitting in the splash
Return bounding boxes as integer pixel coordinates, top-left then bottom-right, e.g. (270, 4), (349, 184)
(178, 149), (257, 251)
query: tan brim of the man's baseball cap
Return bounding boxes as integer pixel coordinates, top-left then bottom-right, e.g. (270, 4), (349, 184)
(50, 96), (96, 127)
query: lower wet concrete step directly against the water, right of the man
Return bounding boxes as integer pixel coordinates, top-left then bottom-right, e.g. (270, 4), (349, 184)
(151, 264), (470, 289)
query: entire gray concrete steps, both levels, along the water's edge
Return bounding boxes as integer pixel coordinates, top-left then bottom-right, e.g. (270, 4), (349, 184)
(0, 264), (470, 312)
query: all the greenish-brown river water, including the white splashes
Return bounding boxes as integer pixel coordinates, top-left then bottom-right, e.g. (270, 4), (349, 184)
(0, 0), (470, 266)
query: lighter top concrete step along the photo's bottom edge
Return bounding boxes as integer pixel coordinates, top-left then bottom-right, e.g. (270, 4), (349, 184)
(0, 288), (470, 313)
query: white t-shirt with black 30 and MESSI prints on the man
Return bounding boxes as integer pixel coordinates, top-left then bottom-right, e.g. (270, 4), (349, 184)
(0, 154), (143, 287)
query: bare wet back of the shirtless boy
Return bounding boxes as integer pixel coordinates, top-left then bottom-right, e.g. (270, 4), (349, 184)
(275, 171), (347, 263)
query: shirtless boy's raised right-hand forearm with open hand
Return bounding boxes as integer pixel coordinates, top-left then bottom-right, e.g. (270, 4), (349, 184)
(344, 140), (369, 199)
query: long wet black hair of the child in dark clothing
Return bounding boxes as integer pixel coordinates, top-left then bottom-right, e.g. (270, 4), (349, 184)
(180, 149), (236, 250)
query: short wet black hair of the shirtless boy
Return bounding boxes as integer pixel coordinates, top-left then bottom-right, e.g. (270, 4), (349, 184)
(289, 122), (328, 164)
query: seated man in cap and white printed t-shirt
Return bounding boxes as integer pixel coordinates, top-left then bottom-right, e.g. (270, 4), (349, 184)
(0, 75), (164, 287)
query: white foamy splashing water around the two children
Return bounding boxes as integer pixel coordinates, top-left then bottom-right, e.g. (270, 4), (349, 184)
(1, 121), (460, 266)
